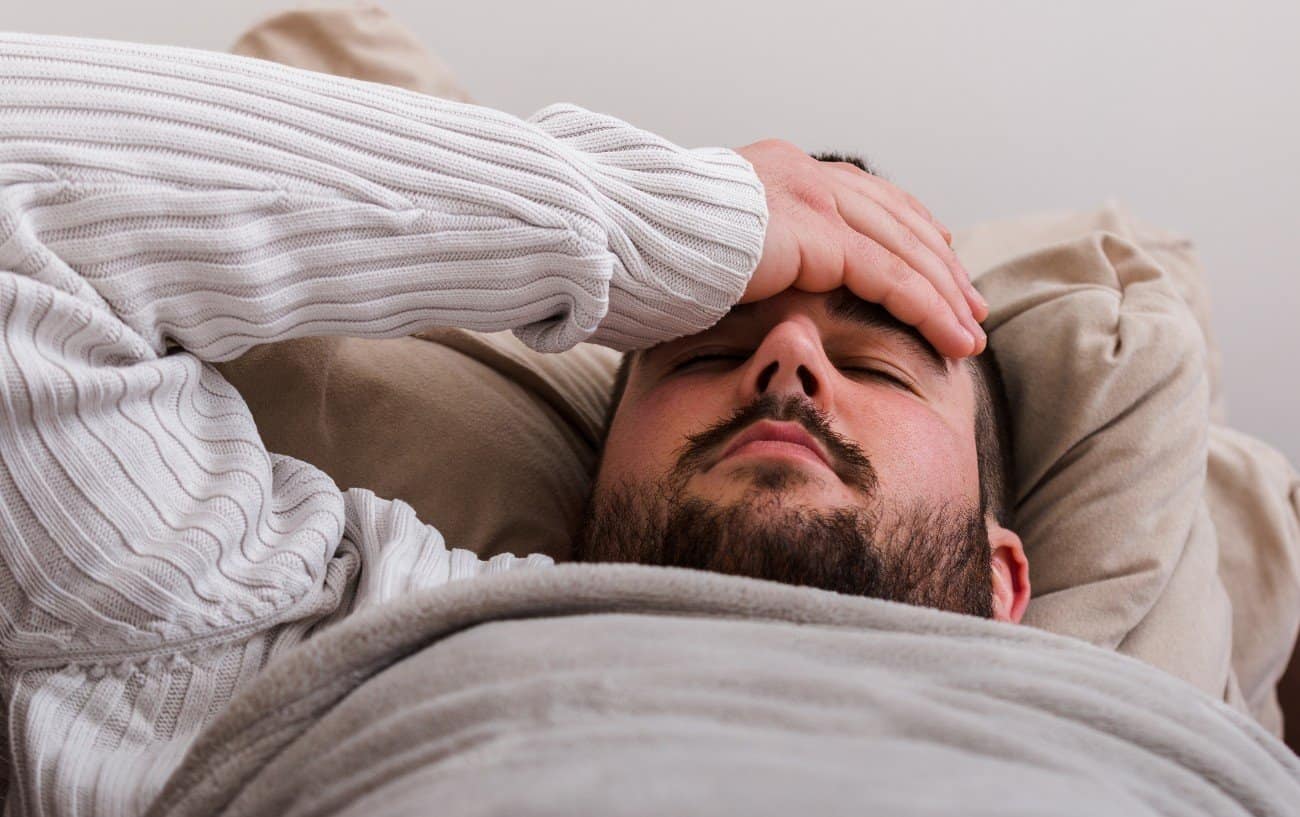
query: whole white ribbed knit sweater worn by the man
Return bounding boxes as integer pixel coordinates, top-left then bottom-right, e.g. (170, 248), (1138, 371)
(0, 34), (767, 817)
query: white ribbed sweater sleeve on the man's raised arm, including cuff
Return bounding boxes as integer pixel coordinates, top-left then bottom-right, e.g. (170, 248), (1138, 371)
(0, 34), (766, 360)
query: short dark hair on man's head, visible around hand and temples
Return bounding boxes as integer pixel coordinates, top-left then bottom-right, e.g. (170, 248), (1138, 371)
(597, 154), (1015, 528)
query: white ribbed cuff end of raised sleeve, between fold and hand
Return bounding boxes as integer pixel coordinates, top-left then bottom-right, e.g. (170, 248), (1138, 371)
(523, 104), (768, 350)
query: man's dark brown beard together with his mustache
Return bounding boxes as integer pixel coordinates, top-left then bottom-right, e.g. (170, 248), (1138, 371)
(573, 397), (993, 618)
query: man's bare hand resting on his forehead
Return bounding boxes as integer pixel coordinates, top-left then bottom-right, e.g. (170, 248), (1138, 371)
(736, 139), (988, 358)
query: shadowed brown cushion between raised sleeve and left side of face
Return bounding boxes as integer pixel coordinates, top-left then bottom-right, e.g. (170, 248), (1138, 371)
(221, 329), (619, 559)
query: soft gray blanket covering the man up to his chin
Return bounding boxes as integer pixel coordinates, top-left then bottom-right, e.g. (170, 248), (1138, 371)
(151, 565), (1300, 817)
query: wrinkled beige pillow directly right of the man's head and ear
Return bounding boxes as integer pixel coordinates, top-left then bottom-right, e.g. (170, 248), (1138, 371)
(979, 233), (1231, 697)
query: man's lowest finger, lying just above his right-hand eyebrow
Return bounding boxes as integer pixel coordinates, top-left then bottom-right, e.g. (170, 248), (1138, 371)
(844, 228), (979, 358)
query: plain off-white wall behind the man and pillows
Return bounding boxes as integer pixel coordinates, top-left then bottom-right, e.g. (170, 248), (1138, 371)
(10, 0), (1300, 463)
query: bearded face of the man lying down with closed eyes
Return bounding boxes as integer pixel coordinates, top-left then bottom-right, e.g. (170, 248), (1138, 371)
(577, 290), (1018, 615)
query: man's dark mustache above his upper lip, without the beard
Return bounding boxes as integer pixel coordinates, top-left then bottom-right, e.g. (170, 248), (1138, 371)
(673, 394), (876, 496)
